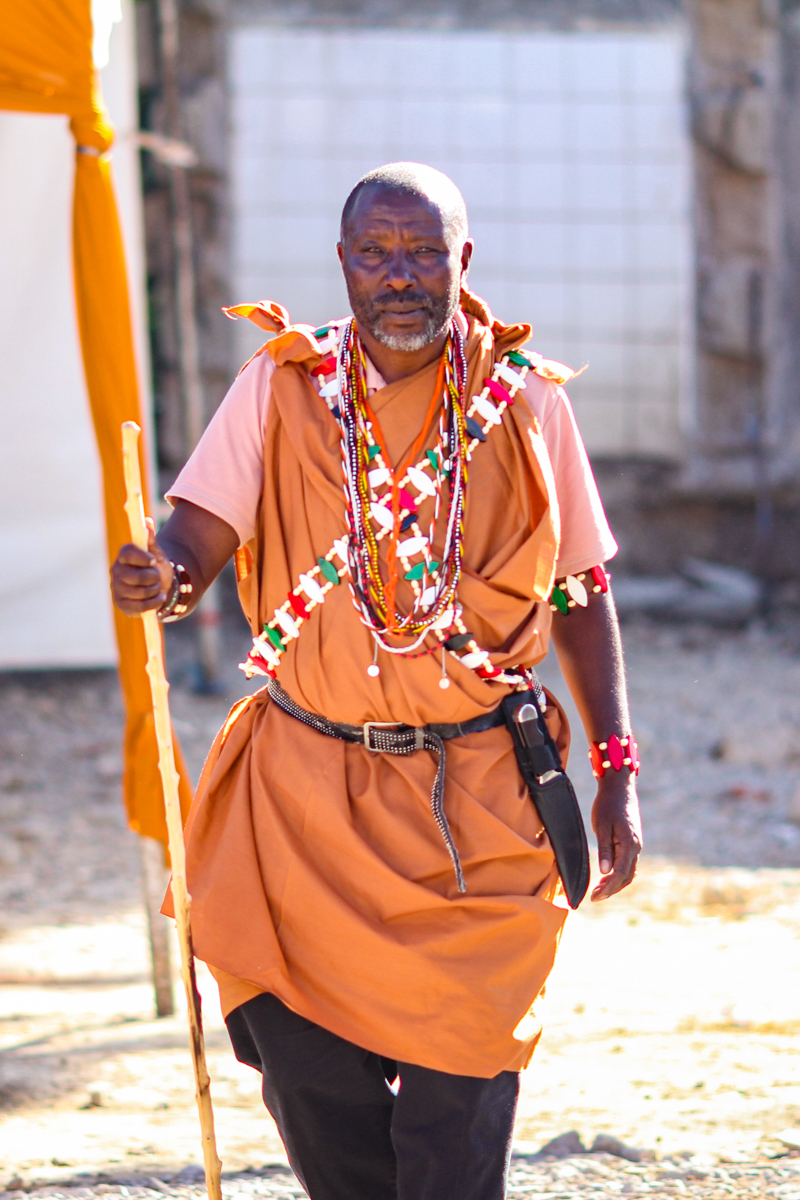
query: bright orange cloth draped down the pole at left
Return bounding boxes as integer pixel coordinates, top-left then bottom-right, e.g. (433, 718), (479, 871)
(0, 0), (191, 842)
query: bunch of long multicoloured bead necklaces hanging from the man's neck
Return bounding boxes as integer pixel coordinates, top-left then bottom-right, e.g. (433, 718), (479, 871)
(338, 318), (468, 654)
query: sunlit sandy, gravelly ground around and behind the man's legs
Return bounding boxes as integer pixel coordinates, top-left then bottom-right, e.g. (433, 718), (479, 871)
(0, 622), (800, 1200)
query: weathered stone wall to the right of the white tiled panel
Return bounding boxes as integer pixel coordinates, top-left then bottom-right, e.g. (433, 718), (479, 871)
(597, 0), (800, 580)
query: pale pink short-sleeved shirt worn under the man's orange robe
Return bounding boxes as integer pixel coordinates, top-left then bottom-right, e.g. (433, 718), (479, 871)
(167, 354), (616, 577)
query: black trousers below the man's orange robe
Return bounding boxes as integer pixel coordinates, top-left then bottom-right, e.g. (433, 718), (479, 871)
(227, 994), (519, 1200)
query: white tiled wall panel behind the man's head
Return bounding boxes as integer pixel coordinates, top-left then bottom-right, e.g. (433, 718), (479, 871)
(230, 26), (692, 456)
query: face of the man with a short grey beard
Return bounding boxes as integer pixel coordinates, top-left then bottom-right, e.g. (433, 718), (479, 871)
(338, 186), (471, 352)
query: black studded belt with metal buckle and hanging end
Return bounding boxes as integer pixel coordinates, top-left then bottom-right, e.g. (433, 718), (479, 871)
(266, 679), (534, 892)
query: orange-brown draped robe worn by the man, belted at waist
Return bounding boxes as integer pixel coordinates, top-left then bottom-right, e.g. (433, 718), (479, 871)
(167, 298), (575, 1078)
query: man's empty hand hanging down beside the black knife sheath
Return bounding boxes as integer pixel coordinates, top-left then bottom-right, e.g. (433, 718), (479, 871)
(591, 770), (642, 900)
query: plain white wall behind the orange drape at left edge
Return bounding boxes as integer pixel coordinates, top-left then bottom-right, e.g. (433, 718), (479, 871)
(0, 6), (146, 668)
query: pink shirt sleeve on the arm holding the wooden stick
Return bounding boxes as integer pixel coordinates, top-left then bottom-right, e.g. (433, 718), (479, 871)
(167, 354), (275, 546)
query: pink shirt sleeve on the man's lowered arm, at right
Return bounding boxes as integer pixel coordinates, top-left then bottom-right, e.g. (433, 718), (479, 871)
(525, 376), (618, 578)
